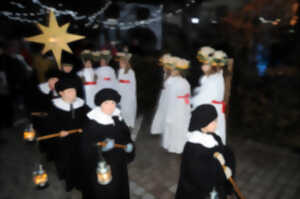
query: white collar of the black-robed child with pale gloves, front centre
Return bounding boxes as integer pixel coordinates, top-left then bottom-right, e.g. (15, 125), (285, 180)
(87, 107), (122, 125)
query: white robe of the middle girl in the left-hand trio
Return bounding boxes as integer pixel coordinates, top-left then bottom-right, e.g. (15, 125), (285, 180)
(95, 66), (118, 93)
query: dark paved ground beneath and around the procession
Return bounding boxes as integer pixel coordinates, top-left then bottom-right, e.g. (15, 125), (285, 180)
(0, 110), (300, 199)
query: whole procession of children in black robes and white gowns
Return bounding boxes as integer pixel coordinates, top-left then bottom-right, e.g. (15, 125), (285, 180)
(26, 47), (235, 199)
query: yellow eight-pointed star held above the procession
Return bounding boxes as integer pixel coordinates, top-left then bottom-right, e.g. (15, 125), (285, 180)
(25, 11), (85, 68)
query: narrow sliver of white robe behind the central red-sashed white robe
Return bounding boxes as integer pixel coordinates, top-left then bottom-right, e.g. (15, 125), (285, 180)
(150, 78), (170, 135)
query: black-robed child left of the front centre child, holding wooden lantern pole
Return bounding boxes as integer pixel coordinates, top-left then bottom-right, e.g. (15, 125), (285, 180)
(42, 78), (90, 191)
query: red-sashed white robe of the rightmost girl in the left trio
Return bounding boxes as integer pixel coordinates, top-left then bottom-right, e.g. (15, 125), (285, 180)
(118, 68), (137, 128)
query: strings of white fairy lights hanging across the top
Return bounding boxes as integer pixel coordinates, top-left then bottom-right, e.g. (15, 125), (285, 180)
(0, 0), (202, 30)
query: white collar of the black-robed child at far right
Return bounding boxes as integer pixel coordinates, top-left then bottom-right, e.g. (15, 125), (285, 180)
(187, 131), (219, 148)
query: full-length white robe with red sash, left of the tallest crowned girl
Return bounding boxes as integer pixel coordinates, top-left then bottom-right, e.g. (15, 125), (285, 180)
(162, 76), (191, 154)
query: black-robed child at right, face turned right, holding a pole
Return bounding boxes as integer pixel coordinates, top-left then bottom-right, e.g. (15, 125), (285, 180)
(176, 104), (235, 199)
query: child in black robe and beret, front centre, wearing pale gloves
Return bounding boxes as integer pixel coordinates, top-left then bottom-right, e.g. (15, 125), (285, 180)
(81, 89), (135, 199)
